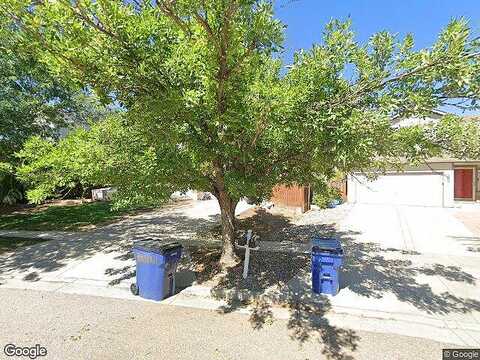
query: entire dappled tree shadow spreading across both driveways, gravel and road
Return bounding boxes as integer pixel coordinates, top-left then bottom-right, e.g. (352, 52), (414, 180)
(0, 204), (480, 359)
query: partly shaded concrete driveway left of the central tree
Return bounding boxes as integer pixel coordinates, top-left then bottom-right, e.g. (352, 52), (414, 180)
(0, 200), (250, 293)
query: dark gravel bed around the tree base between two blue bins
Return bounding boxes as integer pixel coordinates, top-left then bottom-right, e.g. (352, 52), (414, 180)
(180, 204), (350, 293)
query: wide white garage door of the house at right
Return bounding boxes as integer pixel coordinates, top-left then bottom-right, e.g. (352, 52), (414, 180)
(352, 173), (443, 206)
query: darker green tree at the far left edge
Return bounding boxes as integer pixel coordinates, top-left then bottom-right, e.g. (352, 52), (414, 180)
(0, 17), (106, 205)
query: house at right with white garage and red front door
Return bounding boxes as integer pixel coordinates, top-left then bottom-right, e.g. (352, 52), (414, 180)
(347, 111), (480, 207)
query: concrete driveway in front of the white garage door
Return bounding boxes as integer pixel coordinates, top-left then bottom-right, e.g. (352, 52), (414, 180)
(322, 204), (480, 346)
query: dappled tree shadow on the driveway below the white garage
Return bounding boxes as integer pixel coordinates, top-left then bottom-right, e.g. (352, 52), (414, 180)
(338, 233), (480, 315)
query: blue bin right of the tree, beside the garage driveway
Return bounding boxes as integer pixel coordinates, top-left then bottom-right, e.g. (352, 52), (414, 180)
(312, 238), (343, 295)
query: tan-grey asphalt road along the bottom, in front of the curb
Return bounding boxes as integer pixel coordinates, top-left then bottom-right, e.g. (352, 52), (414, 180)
(0, 288), (449, 360)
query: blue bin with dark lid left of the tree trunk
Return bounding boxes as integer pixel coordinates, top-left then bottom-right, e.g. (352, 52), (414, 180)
(131, 239), (182, 301)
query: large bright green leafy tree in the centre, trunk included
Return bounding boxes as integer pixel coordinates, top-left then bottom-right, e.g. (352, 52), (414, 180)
(0, 0), (480, 265)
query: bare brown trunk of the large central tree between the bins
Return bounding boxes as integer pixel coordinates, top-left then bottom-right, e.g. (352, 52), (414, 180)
(217, 191), (239, 268)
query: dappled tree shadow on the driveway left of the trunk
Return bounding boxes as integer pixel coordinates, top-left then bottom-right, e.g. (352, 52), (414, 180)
(0, 206), (217, 285)
